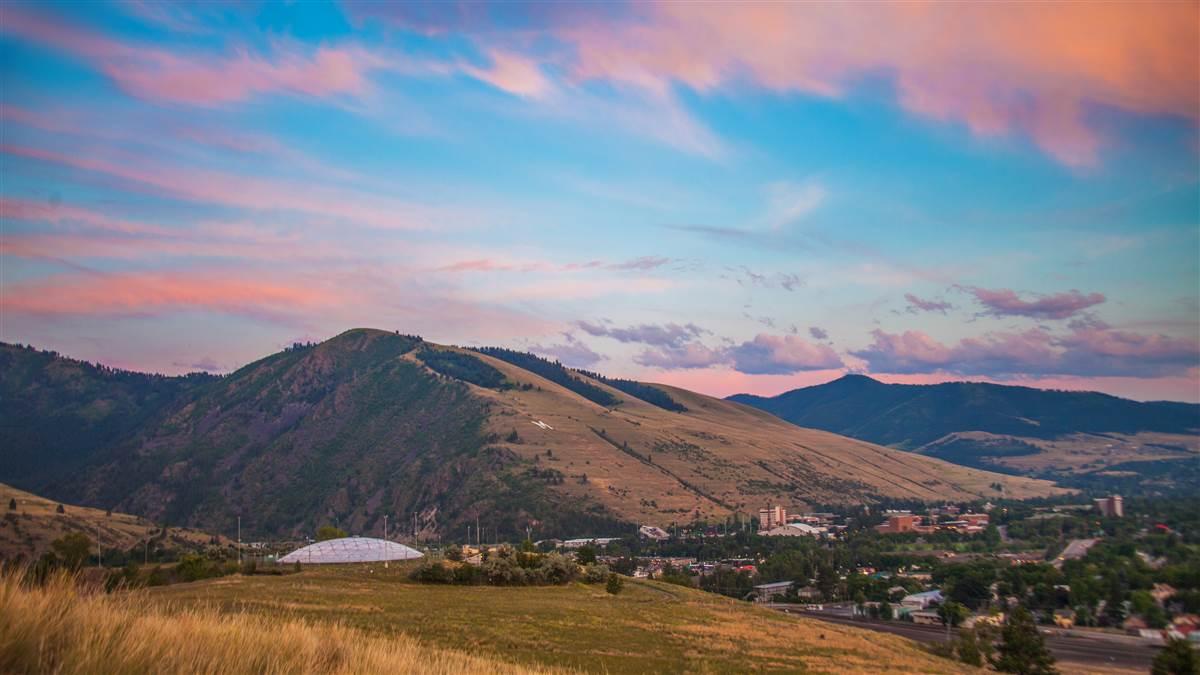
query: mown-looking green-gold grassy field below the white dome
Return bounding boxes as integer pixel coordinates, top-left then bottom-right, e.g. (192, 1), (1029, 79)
(145, 566), (962, 673)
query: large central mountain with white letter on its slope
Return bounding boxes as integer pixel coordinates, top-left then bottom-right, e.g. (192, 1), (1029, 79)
(0, 329), (1057, 538)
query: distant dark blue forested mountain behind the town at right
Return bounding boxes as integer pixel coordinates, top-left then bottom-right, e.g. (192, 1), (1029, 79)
(730, 375), (1200, 488)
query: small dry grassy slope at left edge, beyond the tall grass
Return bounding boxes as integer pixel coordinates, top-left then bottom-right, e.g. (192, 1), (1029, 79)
(0, 483), (229, 560)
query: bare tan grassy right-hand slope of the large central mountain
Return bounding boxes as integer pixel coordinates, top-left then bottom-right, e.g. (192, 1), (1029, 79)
(456, 343), (1063, 525)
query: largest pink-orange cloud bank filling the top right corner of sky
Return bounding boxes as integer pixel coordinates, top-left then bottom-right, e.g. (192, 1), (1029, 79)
(558, 1), (1200, 166)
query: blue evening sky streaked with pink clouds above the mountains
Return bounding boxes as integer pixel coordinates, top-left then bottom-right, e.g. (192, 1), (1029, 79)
(0, 1), (1200, 401)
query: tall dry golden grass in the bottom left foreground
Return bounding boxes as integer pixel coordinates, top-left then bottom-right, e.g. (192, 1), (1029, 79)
(0, 572), (550, 675)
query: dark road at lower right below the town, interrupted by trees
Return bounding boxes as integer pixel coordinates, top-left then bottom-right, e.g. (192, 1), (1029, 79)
(770, 604), (1158, 673)
